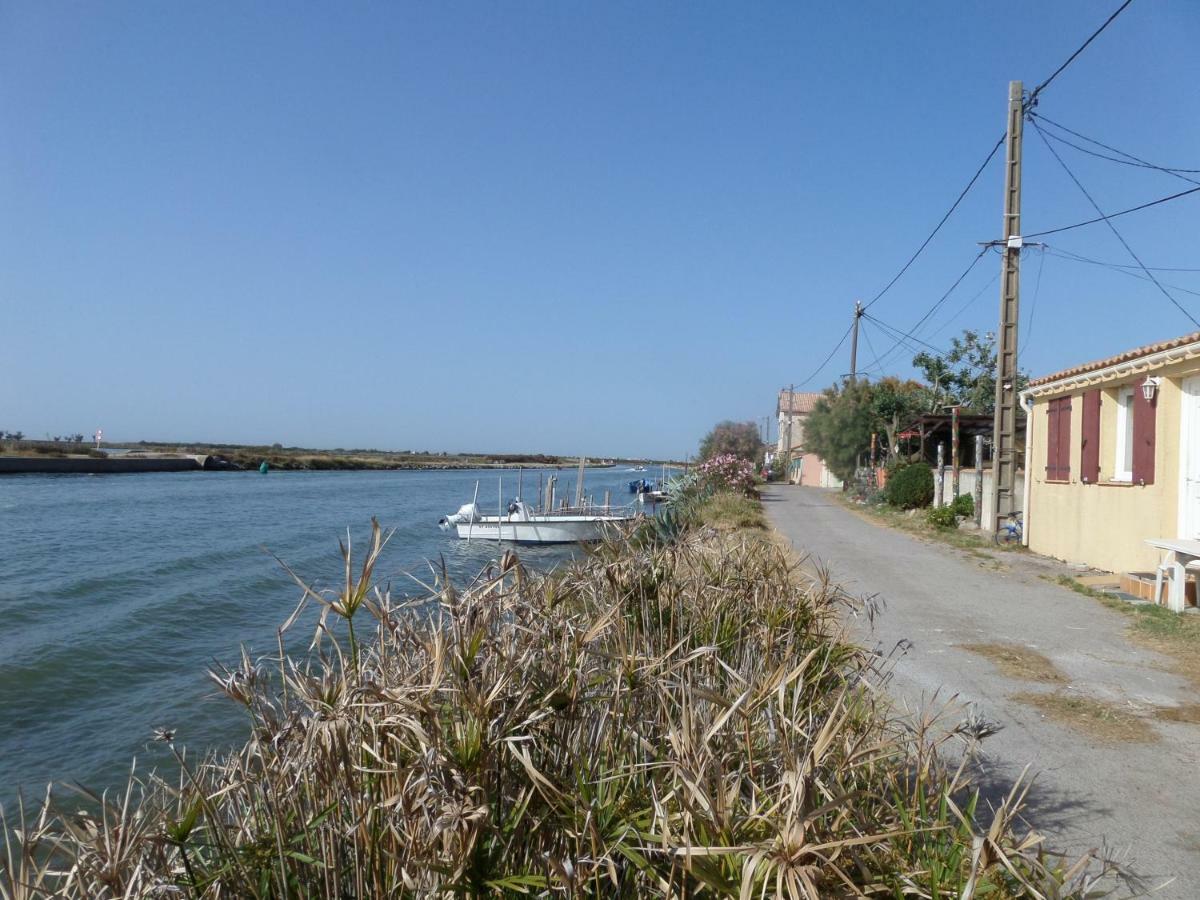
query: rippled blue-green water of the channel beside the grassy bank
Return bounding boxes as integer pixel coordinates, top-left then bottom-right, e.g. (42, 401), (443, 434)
(0, 468), (641, 805)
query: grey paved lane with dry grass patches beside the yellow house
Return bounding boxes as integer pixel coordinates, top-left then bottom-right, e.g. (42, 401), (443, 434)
(764, 486), (1200, 900)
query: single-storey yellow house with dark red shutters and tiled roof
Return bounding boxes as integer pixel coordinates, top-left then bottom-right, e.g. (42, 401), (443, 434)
(1021, 332), (1200, 572)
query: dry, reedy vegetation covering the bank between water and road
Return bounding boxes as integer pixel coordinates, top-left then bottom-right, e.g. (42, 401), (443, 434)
(0, 508), (1099, 899)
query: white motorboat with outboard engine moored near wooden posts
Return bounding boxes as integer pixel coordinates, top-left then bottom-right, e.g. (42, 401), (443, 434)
(439, 498), (636, 544)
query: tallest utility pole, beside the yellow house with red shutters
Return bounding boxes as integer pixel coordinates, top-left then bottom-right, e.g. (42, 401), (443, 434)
(991, 82), (1028, 532)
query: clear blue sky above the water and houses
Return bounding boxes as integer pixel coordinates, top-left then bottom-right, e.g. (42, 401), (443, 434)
(0, 0), (1200, 457)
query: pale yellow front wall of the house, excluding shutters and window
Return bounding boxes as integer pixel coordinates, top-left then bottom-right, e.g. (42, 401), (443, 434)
(1025, 361), (1198, 572)
